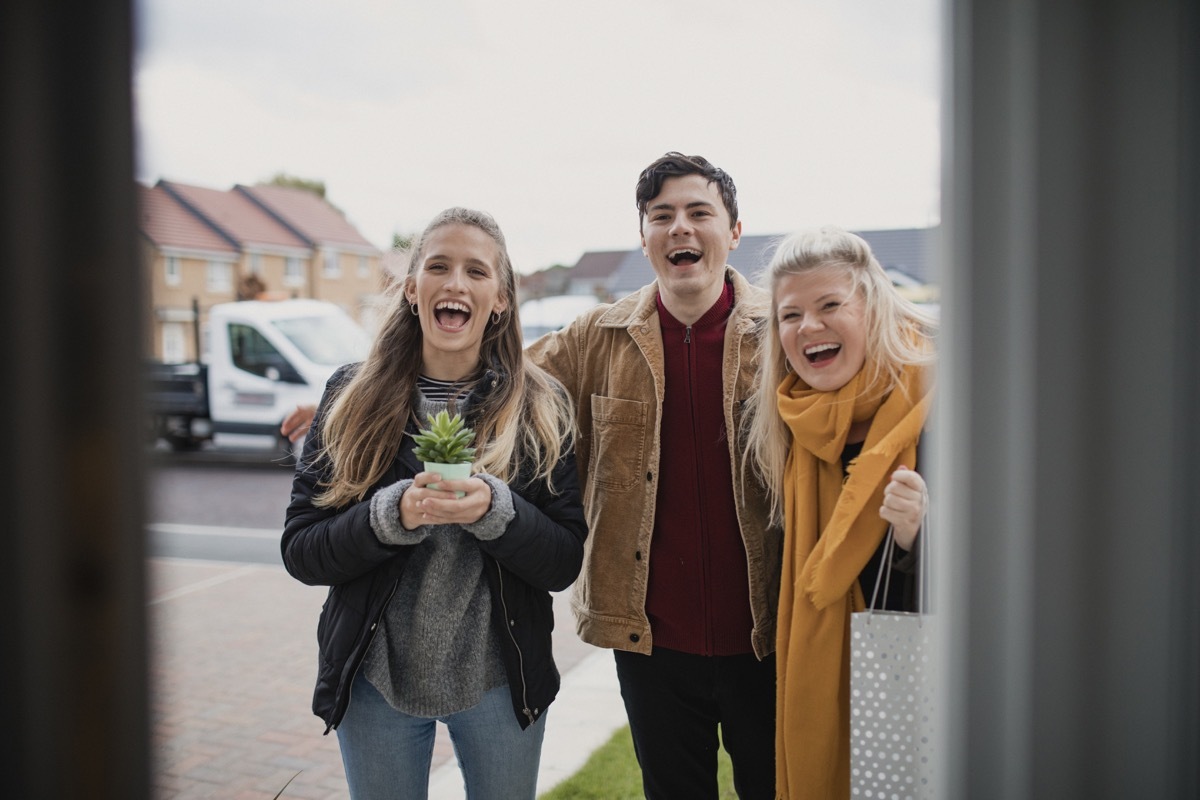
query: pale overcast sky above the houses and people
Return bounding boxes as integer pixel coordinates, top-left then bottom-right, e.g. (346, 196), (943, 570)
(133, 0), (942, 272)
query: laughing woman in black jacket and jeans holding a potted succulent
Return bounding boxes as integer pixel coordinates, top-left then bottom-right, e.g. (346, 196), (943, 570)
(282, 209), (587, 800)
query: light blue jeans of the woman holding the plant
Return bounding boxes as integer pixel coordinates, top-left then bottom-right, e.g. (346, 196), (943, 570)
(337, 672), (546, 800)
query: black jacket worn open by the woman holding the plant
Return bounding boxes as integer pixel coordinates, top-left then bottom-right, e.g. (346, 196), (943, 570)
(282, 367), (587, 733)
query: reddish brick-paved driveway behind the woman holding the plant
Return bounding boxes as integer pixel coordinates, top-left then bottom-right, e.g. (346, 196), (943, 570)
(148, 559), (624, 800)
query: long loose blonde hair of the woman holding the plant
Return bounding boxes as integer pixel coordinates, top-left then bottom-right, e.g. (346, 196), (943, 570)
(313, 207), (575, 507)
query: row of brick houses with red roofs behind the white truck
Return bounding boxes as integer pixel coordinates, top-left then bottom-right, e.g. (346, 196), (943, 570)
(139, 180), (389, 362)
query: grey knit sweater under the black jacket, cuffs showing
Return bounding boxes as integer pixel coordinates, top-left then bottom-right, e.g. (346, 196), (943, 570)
(362, 397), (516, 717)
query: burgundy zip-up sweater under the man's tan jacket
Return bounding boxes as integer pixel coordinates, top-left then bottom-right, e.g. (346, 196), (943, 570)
(646, 283), (754, 656)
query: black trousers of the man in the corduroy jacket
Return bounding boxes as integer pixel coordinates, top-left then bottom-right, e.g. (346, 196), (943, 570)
(616, 648), (775, 800)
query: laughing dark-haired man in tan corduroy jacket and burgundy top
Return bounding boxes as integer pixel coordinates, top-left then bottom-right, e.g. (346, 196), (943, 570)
(528, 152), (781, 800)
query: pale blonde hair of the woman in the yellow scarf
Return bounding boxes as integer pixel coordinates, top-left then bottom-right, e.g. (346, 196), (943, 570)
(743, 225), (937, 523)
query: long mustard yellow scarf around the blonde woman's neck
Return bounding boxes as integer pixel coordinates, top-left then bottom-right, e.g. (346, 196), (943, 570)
(775, 367), (931, 800)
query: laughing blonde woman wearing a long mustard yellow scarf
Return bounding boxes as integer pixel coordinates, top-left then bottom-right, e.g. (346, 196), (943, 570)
(746, 227), (936, 800)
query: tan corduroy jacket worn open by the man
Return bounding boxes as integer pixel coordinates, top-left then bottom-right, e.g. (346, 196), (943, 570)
(527, 267), (782, 658)
